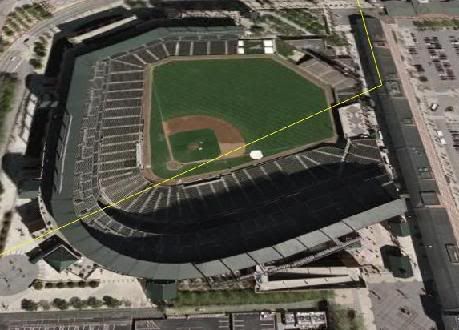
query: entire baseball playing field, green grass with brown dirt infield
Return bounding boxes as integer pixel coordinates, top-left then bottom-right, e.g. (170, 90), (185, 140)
(150, 58), (334, 177)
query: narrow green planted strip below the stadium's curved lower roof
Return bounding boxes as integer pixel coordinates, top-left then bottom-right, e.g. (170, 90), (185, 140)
(174, 289), (333, 307)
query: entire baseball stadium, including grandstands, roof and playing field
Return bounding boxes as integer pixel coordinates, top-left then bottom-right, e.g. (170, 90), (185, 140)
(40, 14), (405, 280)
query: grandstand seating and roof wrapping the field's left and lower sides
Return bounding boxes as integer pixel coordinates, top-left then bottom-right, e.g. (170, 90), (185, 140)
(41, 21), (405, 280)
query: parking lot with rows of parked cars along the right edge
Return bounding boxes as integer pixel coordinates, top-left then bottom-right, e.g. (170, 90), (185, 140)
(400, 27), (459, 203)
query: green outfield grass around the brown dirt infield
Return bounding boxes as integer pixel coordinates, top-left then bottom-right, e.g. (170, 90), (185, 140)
(151, 58), (333, 177)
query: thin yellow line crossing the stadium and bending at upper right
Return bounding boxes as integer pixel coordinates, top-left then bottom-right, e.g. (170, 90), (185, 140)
(0, 0), (383, 257)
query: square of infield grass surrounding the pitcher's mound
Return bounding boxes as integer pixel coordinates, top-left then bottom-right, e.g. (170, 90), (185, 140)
(169, 129), (220, 163)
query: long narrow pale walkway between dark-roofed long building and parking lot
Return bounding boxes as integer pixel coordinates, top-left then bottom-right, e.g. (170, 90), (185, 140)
(381, 20), (459, 239)
